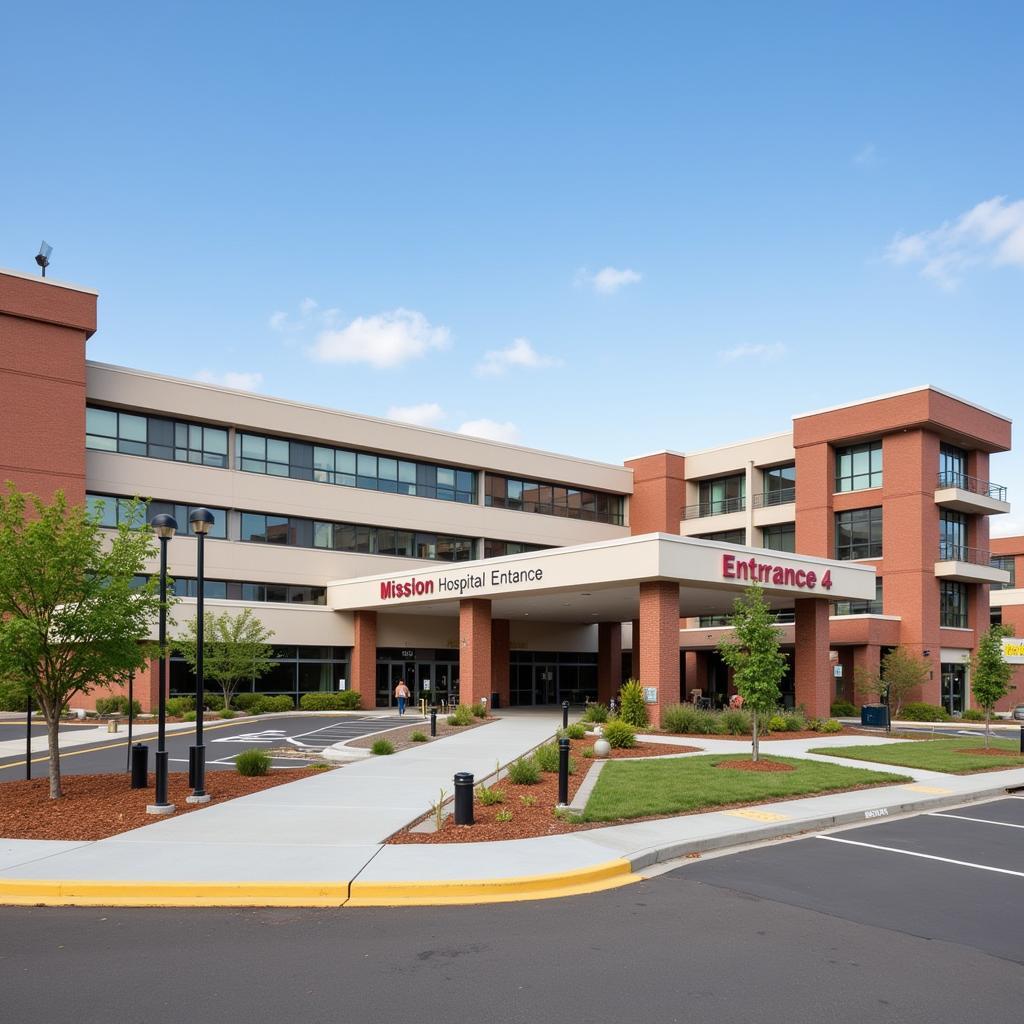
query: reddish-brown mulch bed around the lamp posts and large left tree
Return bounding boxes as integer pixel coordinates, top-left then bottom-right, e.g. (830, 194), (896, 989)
(0, 768), (323, 841)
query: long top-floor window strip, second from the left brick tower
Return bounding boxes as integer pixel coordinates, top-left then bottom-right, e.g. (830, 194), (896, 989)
(234, 431), (476, 505)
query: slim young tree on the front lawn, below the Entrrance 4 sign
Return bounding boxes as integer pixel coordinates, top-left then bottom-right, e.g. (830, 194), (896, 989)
(718, 584), (786, 761)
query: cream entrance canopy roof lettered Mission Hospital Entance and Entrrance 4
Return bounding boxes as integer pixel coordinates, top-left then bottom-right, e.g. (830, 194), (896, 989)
(327, 534), (874, 624)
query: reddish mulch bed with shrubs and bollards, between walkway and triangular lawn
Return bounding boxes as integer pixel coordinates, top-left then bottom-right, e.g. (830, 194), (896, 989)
(388, 737), (700, 844)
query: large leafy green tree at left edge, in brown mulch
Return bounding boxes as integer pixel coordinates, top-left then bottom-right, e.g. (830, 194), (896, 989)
(0, 483), (160, 800)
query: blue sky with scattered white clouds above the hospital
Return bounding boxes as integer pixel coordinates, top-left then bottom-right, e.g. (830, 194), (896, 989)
(0, 8), (1024, 532)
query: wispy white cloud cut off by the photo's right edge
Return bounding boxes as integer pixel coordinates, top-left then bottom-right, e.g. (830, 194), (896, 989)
(886, 196), (1024, 289)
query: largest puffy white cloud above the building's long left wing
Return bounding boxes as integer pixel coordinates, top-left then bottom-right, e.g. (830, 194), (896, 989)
(309, 308), (449, 370)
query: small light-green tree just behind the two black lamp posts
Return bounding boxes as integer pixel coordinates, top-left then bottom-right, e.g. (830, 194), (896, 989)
(174, 608), (278, 711)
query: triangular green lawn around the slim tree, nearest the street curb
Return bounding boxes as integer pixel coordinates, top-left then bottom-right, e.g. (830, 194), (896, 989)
(583, 754), (908, 821)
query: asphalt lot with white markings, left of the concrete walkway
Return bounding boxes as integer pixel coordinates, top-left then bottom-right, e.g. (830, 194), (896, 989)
(0, 714), (405, 781)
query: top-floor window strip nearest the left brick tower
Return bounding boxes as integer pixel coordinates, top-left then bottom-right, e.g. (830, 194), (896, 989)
(85, 406), (227, 469)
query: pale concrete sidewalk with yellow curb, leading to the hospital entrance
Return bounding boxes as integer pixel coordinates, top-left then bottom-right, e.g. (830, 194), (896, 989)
(0, 716), (1024, 907)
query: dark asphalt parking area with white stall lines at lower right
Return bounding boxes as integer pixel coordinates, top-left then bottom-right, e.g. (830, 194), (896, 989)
(666, 795), (1024, 963)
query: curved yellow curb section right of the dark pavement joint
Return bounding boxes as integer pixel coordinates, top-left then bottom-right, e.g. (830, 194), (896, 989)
(345, 858), (640, 906)
